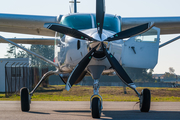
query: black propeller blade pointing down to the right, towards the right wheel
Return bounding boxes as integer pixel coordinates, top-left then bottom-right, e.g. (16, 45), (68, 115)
(102, 43), (136, 89)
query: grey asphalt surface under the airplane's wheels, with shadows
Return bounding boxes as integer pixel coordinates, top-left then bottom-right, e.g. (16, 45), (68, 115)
(0, 101), (180, 120)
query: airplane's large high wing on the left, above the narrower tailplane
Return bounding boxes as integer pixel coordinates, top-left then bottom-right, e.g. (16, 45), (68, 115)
(0, 13), (62, 37)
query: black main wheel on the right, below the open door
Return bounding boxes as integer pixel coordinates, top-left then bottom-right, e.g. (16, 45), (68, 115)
(139, 89), (151, 112)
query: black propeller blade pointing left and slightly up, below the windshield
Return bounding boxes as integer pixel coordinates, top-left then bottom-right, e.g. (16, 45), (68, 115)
(44, 23), (98, 41)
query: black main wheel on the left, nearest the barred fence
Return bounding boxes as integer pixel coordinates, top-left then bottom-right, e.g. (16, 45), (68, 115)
(20, 87), (30, 112)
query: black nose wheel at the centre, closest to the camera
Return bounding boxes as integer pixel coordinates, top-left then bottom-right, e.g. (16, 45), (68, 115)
(91, 97), (101, 118)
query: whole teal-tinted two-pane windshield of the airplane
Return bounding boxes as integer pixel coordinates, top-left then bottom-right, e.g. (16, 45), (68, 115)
(60, 14), (121, 33)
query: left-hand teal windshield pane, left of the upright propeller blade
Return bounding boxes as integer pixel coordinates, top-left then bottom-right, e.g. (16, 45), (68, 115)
(61, 14), (92, 30)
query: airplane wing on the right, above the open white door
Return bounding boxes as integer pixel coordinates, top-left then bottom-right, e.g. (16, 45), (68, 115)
(119, 17), (180, 34)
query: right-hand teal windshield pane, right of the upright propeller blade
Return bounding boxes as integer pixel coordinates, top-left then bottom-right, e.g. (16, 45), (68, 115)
(93, 14), (120, 33)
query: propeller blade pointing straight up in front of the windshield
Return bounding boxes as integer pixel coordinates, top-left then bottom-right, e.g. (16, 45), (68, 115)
(96, 0), (105, 38)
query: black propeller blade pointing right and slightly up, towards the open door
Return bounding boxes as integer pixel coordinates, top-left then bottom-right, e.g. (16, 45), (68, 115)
(104, 22), (154, 41)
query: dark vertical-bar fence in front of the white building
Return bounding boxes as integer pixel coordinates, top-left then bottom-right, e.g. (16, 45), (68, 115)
(5, 62), (34, 97)
